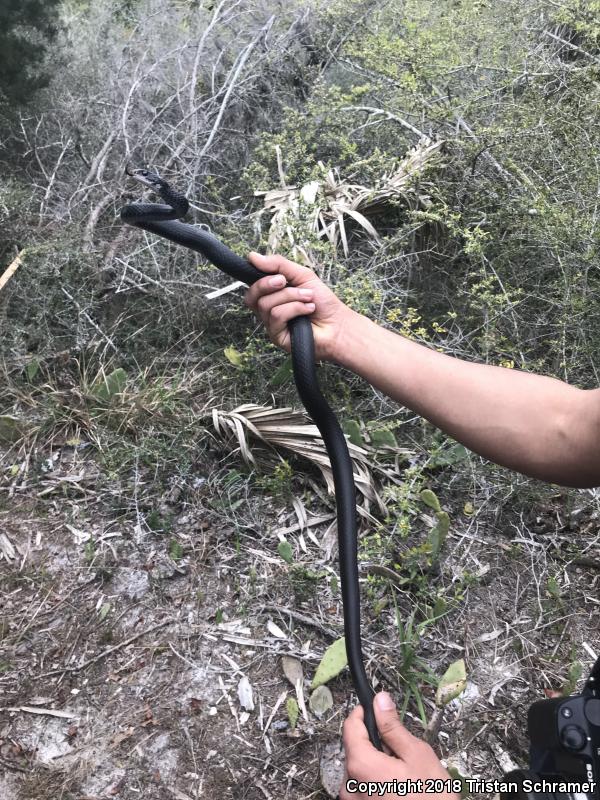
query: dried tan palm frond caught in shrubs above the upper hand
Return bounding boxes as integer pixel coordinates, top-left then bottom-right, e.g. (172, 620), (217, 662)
(254, 137), (444, 265)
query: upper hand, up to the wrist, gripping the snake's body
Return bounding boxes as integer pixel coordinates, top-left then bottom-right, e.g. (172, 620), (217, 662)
(244, 252), (355, 361)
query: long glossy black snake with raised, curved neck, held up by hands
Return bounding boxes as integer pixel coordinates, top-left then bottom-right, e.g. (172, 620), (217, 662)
(121, 168), (381, 750)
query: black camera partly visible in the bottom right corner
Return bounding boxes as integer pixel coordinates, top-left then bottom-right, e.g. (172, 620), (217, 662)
(500, 658), (600, 800)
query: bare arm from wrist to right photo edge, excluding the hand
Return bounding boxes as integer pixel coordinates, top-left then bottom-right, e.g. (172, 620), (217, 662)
(334, 315), (600, 488)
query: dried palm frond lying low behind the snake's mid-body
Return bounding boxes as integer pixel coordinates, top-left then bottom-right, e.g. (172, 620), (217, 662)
(212, 404), (412, 517)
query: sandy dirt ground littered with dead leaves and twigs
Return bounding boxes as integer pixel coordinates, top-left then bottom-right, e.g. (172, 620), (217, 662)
(0, 438), (600, 800)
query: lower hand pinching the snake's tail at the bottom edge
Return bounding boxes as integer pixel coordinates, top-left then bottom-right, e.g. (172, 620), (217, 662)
(339, 692), (460, 800)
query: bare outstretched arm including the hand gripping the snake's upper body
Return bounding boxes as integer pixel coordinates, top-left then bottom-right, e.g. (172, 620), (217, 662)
(247, 254), (600, 488)
